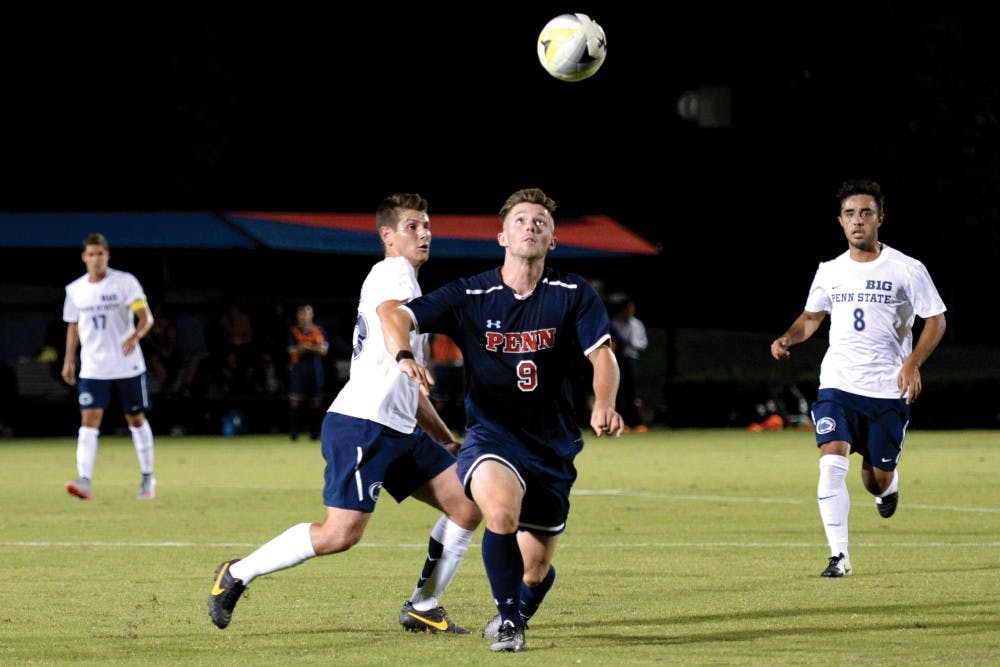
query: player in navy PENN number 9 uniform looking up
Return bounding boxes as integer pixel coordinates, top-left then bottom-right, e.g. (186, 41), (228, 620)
(381, 188), (624, 651)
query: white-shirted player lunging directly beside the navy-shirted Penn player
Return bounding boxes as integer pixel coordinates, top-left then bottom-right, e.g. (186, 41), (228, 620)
(208, 194), (481, 634)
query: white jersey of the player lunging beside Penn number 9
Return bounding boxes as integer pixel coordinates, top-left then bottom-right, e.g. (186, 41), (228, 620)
(330, 257), (427, 433)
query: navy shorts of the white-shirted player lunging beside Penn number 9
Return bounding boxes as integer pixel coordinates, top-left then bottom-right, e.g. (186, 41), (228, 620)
(320, 412), (455, 512)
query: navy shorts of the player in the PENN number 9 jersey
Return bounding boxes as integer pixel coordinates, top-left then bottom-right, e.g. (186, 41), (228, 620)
(458, 427), (576, 535)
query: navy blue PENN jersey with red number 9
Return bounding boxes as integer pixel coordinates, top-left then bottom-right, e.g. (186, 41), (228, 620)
(407, 268), (611, 458)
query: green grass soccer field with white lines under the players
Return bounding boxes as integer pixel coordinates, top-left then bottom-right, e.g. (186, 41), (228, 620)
(0, 430), (1000, 667)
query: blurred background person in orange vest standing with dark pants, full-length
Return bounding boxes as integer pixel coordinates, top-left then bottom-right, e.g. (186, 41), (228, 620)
(288, 304), (330, 440)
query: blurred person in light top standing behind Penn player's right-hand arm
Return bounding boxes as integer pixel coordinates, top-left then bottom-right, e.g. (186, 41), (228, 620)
(608, 292), (649, 432)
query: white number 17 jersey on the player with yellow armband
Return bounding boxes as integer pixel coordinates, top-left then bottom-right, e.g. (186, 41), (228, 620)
(63, 268), (146, 380)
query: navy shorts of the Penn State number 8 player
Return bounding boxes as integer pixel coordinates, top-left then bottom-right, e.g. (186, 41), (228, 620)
(812, 389), (910, 470)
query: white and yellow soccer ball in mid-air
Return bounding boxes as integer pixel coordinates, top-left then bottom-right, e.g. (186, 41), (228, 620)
(538, 13), (608, 81)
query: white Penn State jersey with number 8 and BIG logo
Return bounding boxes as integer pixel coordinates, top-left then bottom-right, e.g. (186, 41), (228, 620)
(805, 244), (946, 398)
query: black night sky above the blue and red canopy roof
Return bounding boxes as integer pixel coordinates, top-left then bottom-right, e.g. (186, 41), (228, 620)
(0, 1), (1000, 339)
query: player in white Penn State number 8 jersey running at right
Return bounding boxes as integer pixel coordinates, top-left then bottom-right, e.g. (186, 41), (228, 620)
(771, 181), (945, 577)
